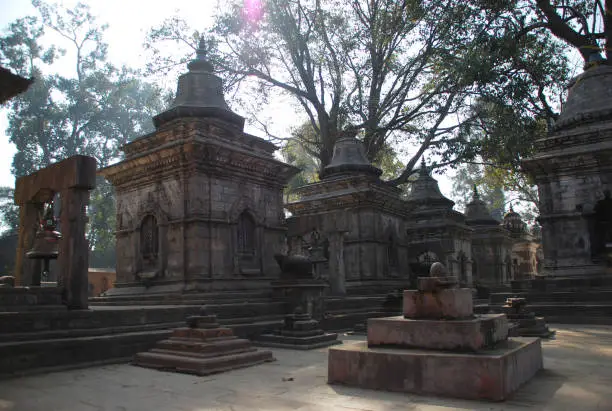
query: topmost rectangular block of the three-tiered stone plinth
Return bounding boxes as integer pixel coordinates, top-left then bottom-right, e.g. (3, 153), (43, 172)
(404, 288), (474, 319)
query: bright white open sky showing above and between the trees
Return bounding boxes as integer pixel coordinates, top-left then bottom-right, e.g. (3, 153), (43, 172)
(0, 0), (460, 199)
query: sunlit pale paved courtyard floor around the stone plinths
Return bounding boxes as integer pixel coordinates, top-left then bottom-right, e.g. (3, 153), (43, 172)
(0, 325), (612, 411)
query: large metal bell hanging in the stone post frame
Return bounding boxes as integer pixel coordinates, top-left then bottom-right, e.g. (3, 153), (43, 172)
(26, 202), (62, 285)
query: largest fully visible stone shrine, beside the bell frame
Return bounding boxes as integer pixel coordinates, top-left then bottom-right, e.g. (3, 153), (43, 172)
(100, 39), (298, 296)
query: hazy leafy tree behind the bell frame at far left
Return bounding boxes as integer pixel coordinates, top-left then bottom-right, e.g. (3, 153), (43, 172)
(0, 0), (164, 265)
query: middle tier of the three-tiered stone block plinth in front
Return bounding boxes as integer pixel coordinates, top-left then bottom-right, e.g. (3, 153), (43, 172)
(368, 314), (508, 351)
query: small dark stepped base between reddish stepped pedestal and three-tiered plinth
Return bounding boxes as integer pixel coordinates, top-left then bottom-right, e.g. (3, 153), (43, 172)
(257, 310), (342, 350)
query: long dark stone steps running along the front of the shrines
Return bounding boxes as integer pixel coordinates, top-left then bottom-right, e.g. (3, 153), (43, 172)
(0, 288), (401, 377)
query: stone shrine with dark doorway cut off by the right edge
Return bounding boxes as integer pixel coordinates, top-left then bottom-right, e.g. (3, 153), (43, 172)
(523, 64), (612, 278)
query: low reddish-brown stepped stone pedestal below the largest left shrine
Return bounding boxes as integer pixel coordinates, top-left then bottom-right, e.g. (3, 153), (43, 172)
(132, 315), (274, 375)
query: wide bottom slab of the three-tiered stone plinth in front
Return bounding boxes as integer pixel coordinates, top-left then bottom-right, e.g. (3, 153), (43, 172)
(327, 338), (543, 401)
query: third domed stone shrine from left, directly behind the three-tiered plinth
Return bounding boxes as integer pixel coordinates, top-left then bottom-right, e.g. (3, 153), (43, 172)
(405, 160), (473, 287)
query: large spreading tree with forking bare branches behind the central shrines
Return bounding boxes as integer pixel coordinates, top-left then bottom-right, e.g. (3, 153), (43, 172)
(146, 0), (567, 190)
